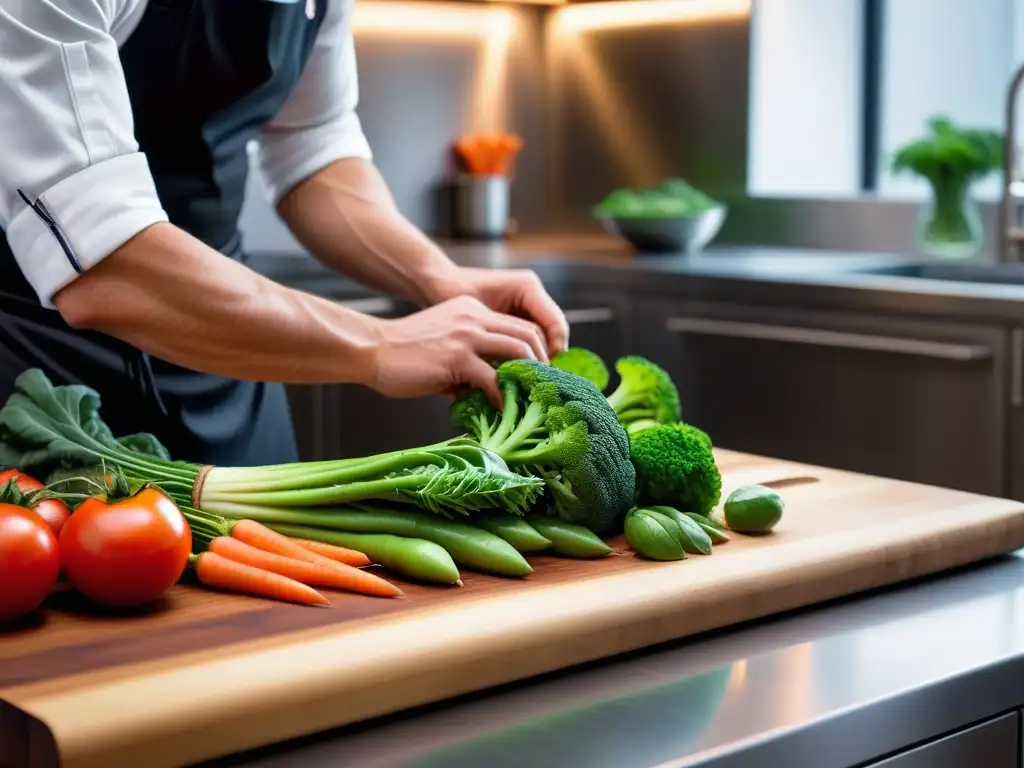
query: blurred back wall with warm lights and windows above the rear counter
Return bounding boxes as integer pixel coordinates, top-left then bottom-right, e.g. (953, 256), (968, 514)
(237, 0), (1024, 255)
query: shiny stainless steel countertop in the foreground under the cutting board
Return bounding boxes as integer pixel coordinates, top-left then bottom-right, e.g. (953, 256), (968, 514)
(209, 553), (1024, 768)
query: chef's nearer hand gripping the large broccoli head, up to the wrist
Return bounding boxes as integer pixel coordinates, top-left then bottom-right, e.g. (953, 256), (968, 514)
(369, 296), (546, 407)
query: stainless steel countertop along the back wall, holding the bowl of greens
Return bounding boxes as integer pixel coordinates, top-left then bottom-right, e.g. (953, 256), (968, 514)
(250, 238), (1024, 324)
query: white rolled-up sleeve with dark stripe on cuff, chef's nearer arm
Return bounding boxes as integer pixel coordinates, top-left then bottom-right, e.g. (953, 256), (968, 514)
(0, 0), (167, 307)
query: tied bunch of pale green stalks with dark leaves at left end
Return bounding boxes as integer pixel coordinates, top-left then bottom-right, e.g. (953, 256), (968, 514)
(0, 370), (544, 514)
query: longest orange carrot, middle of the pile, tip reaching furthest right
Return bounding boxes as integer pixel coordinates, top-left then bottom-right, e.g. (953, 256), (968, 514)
(209, 536), (401, 597)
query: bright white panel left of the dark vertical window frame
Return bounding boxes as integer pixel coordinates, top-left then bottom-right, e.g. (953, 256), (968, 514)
(748, 0), (864, 197)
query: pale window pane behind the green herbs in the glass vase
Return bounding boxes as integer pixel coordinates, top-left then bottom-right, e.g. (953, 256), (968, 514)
(876, 0), (1024, 200)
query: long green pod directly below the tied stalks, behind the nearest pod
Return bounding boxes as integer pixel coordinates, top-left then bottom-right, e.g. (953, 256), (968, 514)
(204, 502), (534, 577)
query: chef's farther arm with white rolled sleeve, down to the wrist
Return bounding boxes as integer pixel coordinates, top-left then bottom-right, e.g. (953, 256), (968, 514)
(258, 2), (471, 306)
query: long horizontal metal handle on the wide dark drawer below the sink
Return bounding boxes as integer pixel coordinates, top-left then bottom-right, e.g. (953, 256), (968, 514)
(666, 317), (992, 361)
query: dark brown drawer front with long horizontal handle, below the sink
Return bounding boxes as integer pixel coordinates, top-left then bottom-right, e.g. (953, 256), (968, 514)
(636, 299), (1009, 495)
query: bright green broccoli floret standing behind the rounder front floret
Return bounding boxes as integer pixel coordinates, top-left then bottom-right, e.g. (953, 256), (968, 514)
(608, 355), (682, 435)
